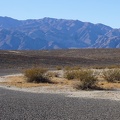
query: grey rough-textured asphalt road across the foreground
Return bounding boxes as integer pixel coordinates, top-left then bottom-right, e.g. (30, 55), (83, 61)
(0, 88), (120, 120)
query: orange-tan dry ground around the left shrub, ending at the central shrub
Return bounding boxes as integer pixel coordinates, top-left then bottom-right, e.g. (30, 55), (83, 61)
(0, 75), (76, 89)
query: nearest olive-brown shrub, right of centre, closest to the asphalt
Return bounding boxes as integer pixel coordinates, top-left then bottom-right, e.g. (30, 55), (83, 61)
(75, 70), (98, 90)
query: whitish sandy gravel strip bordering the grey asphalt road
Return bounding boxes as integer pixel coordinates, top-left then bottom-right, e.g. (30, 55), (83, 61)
(0, 74), (120, 101)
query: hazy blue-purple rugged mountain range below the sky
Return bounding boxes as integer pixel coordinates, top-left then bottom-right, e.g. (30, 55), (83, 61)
(0, 17), (120, 50)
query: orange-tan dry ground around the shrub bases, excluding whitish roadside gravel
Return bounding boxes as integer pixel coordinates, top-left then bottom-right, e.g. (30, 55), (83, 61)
(0, 75), (120, 89)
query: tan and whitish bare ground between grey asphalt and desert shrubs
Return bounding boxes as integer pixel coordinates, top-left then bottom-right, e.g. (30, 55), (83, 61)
(0, 75), (120, 101)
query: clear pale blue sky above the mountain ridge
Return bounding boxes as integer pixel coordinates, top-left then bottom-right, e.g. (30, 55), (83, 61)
(0, 0), (120, 28)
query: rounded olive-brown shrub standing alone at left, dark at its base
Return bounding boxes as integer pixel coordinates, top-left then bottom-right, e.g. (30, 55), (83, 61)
(24, 68), (51, 83)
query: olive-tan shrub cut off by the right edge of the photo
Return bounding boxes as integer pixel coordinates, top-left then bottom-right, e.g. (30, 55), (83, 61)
(103, 69), (120, 82)
